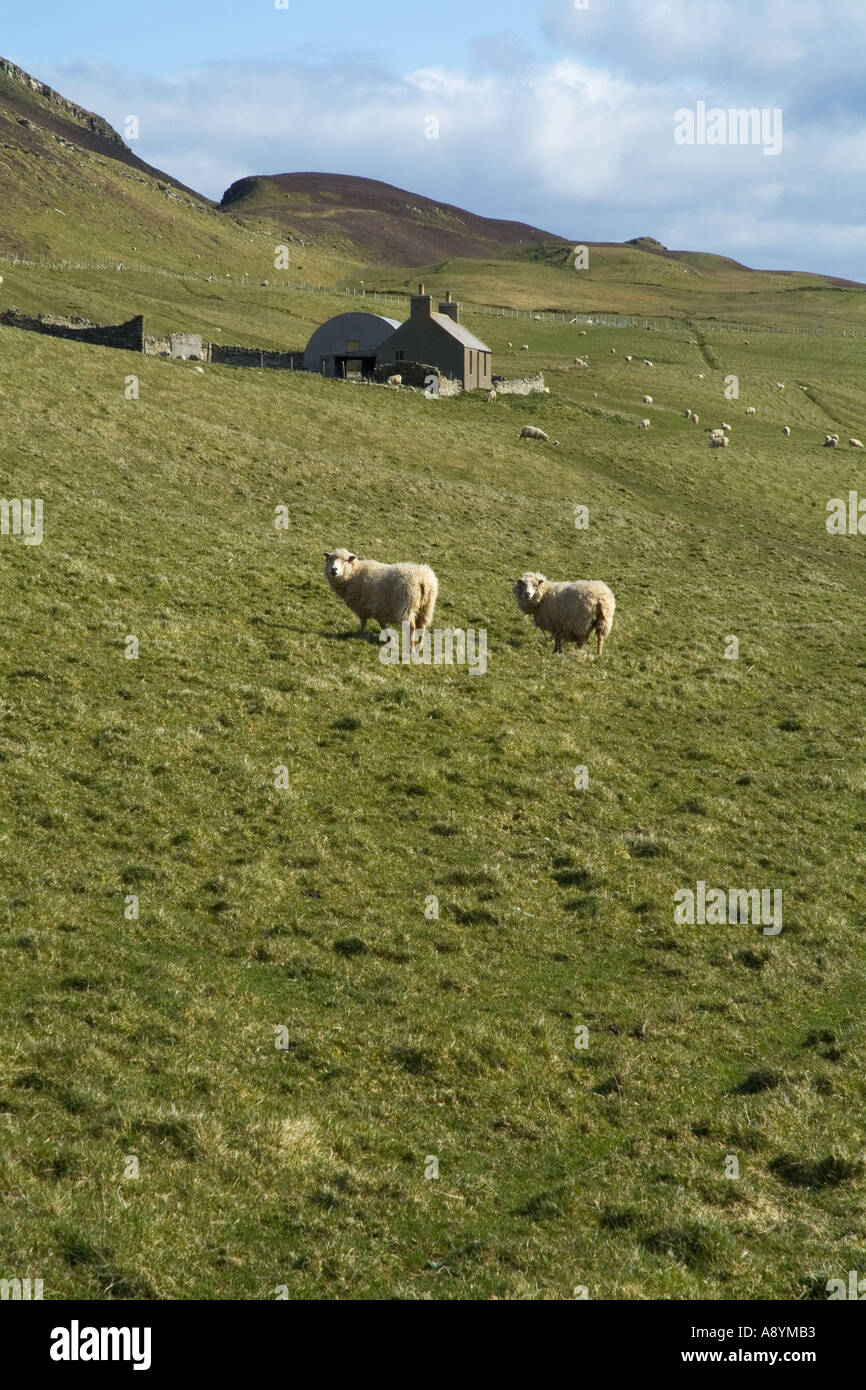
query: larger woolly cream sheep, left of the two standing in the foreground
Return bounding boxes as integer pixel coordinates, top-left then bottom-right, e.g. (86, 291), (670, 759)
(324, 550), (439, 645)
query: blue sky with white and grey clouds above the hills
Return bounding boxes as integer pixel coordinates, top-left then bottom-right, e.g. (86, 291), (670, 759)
(6, 0), (866, 281)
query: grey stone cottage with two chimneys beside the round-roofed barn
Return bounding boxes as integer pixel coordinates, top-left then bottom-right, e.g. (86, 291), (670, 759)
(375, 285), (491, 391)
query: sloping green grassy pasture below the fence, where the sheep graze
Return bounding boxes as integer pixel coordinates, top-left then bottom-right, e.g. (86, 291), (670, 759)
(0, 271), (866, 1300)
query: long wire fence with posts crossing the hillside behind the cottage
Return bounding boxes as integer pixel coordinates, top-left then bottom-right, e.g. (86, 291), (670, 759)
(0, 256), (866, 339)
